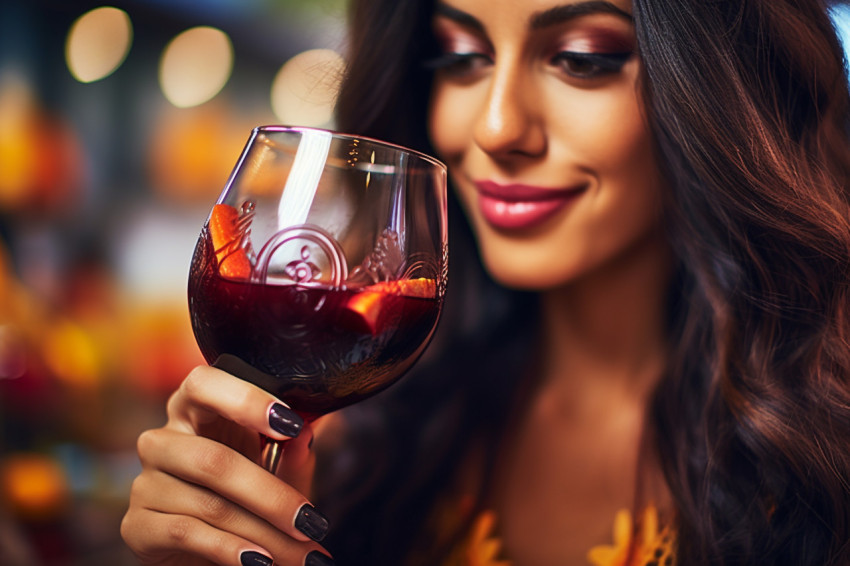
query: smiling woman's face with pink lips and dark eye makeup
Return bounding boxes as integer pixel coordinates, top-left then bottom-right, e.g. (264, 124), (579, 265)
(429, 0), (662, 289)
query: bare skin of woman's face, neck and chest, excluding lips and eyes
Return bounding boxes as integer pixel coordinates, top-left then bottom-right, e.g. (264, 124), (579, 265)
(429, 0), (671, 566)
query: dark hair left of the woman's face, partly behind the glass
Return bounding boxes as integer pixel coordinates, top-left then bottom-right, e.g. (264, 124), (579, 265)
(315, 0), (537, 566)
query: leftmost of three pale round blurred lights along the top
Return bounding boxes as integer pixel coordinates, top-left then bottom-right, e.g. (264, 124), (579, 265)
(65, 6), (133, 83)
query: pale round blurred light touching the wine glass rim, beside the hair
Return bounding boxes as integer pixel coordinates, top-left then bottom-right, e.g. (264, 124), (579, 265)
(271, 49), (345, 127)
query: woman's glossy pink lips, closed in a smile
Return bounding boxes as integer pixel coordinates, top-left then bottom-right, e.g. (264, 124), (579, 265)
(475, 181), (584, 230)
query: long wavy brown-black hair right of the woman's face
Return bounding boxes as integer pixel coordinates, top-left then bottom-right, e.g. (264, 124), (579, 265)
(634, 0), (850, 564)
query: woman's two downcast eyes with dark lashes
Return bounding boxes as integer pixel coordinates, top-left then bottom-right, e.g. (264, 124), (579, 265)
(425, 51), (632, 79)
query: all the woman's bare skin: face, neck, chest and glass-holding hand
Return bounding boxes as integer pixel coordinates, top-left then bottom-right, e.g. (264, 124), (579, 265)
(122, 0), (671, 566)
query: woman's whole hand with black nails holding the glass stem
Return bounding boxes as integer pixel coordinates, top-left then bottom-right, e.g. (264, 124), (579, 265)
(121, 366), (333, 566)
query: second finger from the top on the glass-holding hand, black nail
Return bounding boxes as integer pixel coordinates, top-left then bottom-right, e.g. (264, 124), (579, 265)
(139, 429), (328, 541)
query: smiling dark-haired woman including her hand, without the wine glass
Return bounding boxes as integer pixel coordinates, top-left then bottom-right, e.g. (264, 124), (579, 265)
(117, 0), (850, 566)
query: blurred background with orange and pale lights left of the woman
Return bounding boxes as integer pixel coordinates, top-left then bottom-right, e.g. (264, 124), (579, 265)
(0, 0), (346, 566)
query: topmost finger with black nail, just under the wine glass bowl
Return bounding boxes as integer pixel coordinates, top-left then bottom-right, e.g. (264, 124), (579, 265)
(168, 366), (304, 440)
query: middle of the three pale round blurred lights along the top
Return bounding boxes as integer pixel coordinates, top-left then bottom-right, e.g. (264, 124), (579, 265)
(159, 26), (233, 108)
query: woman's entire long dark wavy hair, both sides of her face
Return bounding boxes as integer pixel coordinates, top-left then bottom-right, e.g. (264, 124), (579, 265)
(319, 0), (850, 565)
